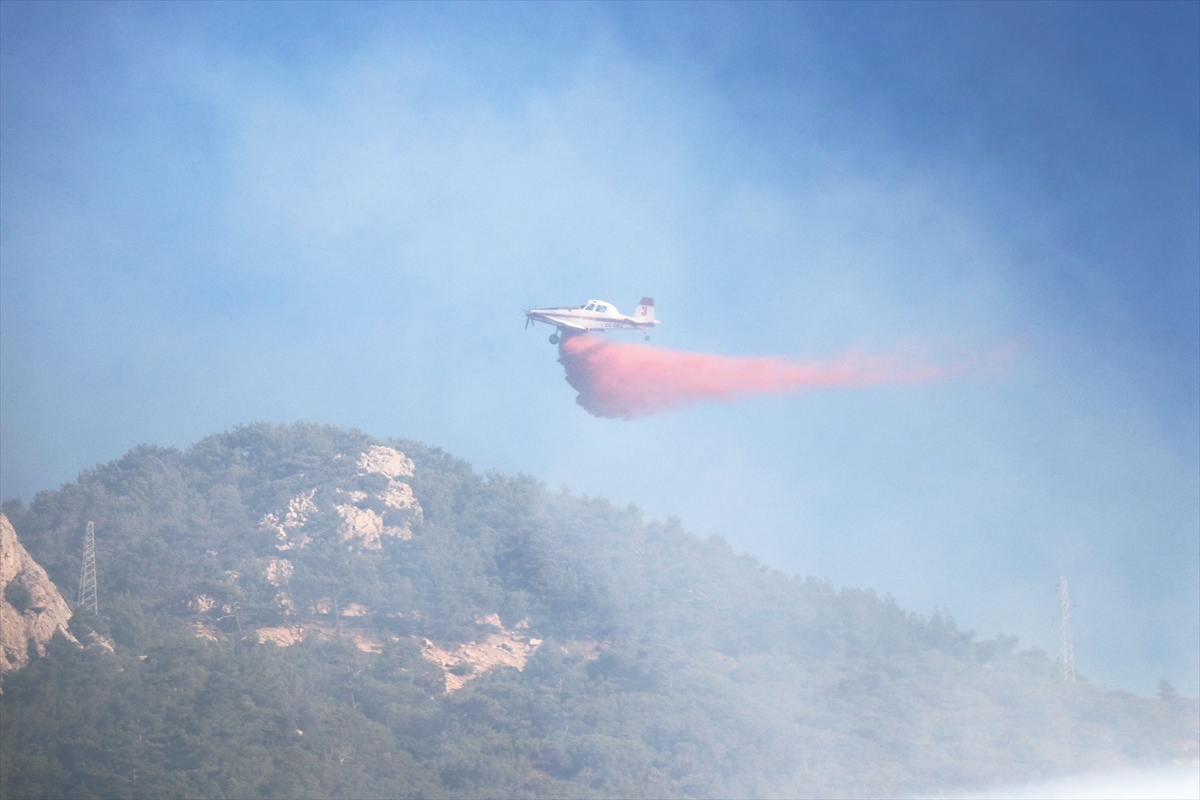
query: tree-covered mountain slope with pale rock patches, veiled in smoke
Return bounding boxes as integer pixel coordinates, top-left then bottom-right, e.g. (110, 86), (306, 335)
(0, 425), (1198, 798)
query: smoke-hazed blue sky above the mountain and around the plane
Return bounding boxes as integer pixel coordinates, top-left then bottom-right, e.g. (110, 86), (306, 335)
(0, 1), (1200, 693)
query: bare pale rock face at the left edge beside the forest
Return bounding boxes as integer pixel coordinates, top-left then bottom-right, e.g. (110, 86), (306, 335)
(0, 513), (76, 675)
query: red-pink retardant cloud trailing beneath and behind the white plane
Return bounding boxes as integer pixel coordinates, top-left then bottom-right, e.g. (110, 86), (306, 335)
(558, 336), (961, 420)
